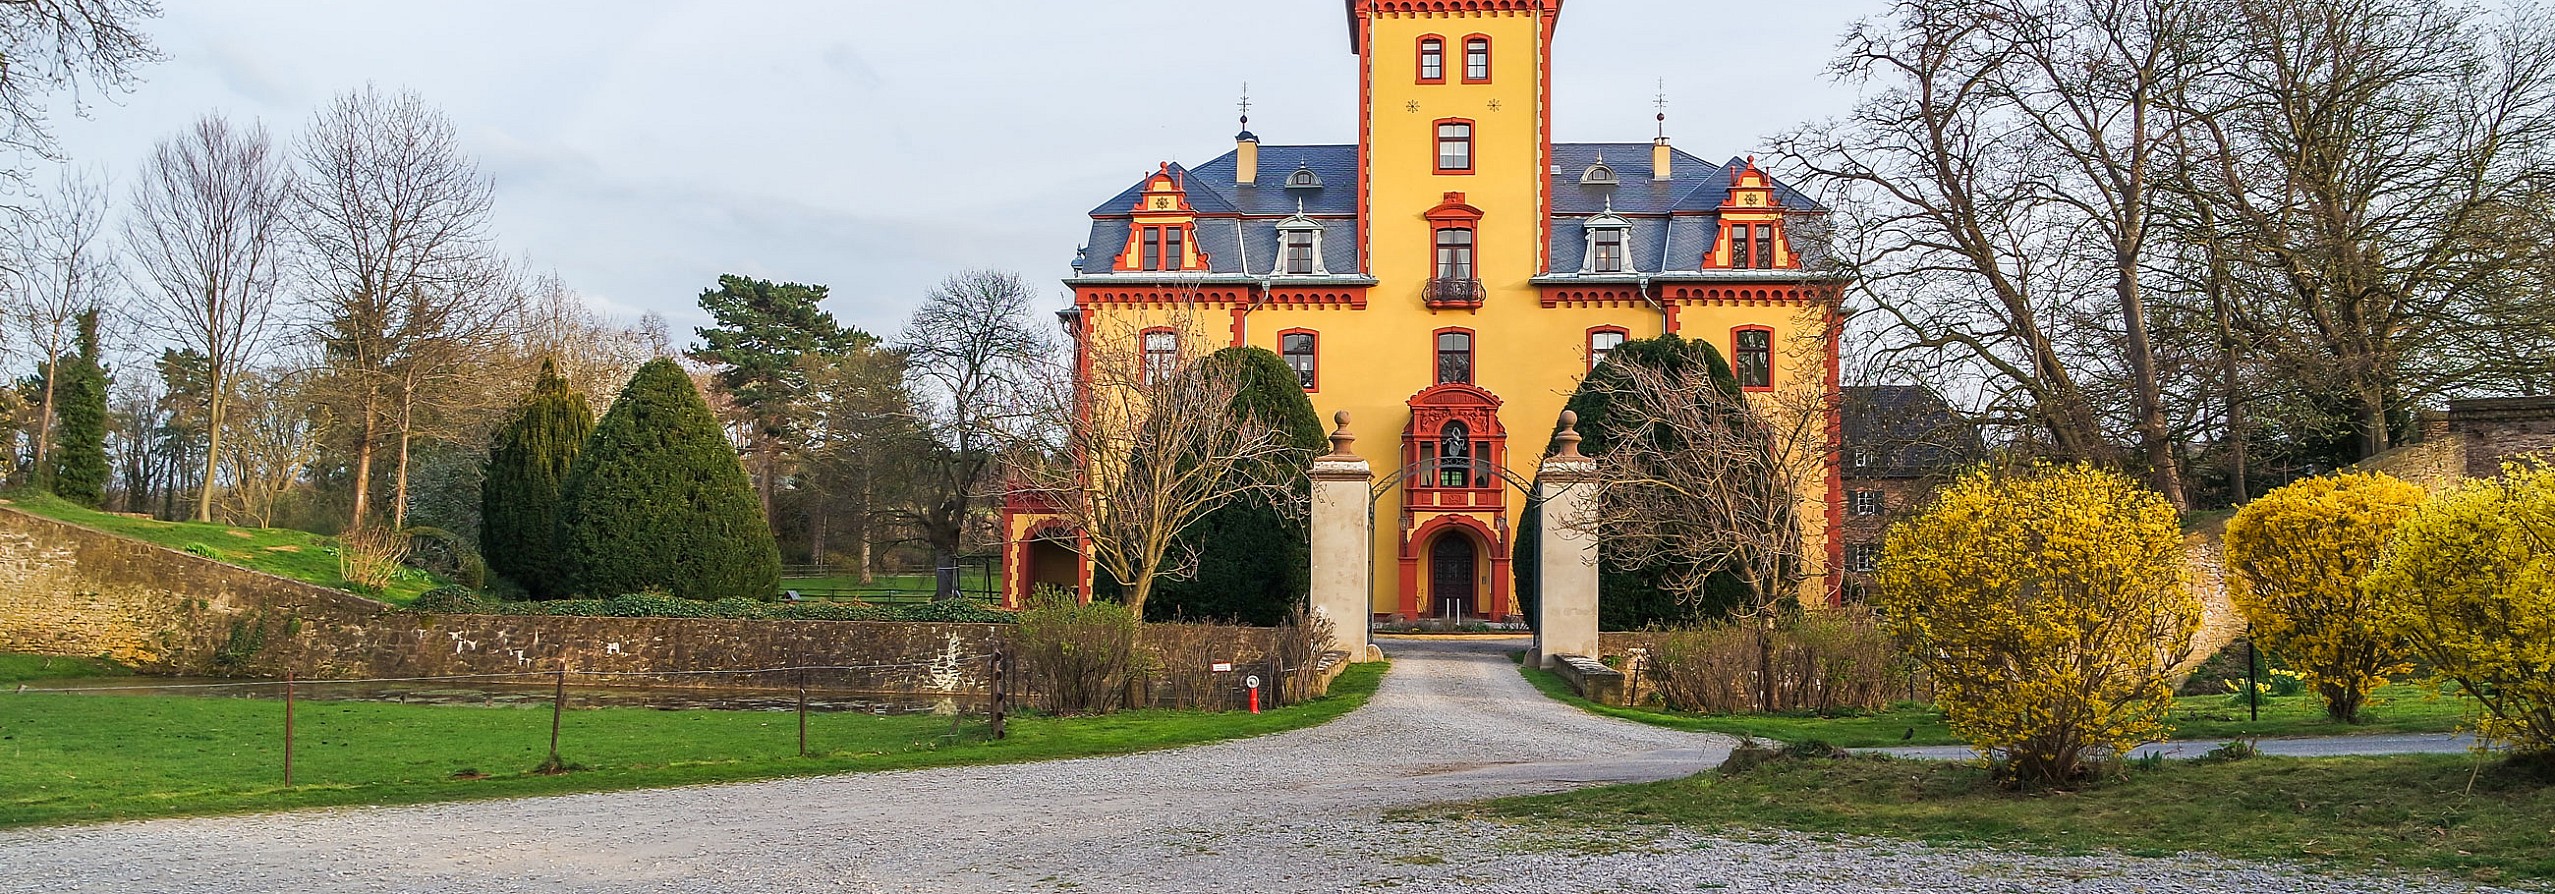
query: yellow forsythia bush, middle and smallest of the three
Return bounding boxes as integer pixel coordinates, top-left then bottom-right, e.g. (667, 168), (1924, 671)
(2225, 473), (2427, 723)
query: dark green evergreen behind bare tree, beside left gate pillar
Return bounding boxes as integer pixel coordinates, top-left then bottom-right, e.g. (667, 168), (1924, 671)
(1145, 347), (1329, 626)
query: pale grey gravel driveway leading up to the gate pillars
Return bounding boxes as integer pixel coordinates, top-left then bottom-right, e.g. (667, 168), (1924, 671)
(0, 641), (2514, 894)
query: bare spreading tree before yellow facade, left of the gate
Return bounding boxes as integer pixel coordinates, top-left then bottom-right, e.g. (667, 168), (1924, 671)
(1014, 312), (1306, 618)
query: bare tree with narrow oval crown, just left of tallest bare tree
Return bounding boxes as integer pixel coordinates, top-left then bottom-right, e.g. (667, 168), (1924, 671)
(125, 115), (291, 521)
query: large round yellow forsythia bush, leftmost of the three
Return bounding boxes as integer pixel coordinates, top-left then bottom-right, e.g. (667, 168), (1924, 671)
(1875, 465), (2200, 784)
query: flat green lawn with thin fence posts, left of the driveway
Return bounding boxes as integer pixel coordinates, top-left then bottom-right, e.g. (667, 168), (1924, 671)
(0, 664), (1385, 825)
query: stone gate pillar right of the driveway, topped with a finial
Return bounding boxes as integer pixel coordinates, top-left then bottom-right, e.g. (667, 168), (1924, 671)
(1533, 411), (1597, 667)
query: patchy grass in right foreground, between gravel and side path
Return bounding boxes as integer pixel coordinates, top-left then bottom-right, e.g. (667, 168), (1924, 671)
(1459, 756), (2555, 881)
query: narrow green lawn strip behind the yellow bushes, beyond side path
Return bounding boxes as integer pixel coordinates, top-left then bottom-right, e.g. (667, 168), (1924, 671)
(1523, 667), (2473, 748)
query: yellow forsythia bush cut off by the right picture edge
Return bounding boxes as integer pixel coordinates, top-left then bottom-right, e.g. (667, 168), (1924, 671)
(2366, 462), (2555, 754)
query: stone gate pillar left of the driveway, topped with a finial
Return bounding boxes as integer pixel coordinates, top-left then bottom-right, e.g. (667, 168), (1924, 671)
(1308, 411), (1375, 662)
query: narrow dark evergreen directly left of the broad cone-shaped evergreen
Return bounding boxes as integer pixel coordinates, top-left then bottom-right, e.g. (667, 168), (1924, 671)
(480, 360), (595, 600)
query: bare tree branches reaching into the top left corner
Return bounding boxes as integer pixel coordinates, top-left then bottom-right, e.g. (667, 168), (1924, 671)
(0, 0), (161, 200)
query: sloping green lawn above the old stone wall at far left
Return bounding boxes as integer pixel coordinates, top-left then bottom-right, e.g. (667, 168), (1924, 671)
(5, 493), (442, 605)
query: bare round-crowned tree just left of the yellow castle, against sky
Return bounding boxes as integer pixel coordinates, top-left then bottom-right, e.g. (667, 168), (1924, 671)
(894, 271), (1071, 598)
